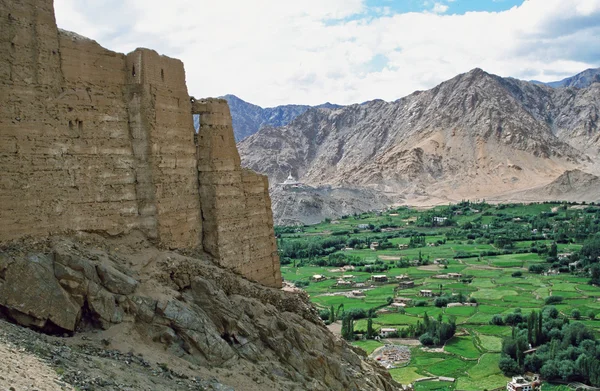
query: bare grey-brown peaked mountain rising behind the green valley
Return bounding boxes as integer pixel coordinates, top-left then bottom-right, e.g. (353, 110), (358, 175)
(238, 69), (600, 224)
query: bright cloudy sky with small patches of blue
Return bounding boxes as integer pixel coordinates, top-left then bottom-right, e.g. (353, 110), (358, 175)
(54, 0), (600, 107)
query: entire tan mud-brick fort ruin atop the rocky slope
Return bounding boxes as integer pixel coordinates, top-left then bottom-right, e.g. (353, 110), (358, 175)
(0, 0), (281, 287)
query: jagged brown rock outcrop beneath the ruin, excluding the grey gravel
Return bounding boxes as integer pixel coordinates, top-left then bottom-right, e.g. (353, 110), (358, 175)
(0, 235), (404, 390)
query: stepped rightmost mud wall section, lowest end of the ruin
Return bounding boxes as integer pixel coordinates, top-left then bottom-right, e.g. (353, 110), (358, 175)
(192, 99), (281, 286)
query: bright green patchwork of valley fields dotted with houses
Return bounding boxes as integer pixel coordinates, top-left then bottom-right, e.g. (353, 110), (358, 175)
(278, 203), (600, 391)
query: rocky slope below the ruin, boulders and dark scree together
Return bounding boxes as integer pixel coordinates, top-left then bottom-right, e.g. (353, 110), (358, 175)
(0, 233), (398, 391)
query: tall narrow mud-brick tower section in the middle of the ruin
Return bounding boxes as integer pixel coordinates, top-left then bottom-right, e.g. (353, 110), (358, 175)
(125, 49), (202, 248)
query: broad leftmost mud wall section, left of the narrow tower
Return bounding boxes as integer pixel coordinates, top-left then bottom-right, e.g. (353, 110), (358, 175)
(0, 1), (137, 240)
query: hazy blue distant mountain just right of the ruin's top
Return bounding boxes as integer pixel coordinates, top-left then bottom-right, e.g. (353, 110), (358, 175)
(202, 95), (340, 141)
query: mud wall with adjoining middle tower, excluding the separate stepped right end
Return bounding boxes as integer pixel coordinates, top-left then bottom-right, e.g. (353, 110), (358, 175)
(0, 1), (200, 247)
